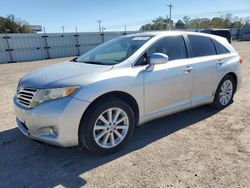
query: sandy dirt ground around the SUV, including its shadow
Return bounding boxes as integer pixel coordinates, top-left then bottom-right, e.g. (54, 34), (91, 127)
(0, 42), (250, 187)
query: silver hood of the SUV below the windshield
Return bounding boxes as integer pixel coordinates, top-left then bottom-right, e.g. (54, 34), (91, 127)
(20, 62), (113, 89)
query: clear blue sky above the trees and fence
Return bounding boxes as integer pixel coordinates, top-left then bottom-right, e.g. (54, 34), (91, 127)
(0, 0), (250, 32)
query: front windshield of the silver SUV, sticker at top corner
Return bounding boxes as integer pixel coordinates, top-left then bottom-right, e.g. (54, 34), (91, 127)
(75, 36), (151, 65)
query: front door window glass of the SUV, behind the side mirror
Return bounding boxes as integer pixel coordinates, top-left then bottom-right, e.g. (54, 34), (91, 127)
(147, 36), (187, 60)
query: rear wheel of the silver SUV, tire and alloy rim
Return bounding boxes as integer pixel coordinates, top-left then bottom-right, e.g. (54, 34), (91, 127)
(213, 75), (236, 109)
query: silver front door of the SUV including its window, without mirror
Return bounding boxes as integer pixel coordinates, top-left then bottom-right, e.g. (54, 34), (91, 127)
(144, 36), (194, 116)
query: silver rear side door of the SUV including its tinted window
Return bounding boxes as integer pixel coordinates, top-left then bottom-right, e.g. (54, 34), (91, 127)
(188, 35), (223, 105)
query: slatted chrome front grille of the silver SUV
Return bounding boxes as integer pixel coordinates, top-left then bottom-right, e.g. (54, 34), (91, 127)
(17, 88), (37, 108)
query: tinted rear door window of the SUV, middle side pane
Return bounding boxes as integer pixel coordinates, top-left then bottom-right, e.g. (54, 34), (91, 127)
(188, 35), (216, 57)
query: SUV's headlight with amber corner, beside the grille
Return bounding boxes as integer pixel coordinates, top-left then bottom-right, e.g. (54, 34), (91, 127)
(30, 86), (79, 108)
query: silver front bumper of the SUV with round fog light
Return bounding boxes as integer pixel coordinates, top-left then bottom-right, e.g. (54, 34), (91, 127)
(13, 97), (89, 147)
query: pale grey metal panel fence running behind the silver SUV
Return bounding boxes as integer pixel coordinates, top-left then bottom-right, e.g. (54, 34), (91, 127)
(0, 26), (246, 63)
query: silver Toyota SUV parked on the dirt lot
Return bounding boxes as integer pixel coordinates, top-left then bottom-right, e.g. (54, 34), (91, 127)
(14, 32), (242, 154)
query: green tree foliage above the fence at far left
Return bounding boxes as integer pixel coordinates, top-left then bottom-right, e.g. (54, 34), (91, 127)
(0, 15), (33, 33)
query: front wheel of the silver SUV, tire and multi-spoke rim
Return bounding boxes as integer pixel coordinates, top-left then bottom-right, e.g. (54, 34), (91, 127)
(79, 98), (135, 154)
